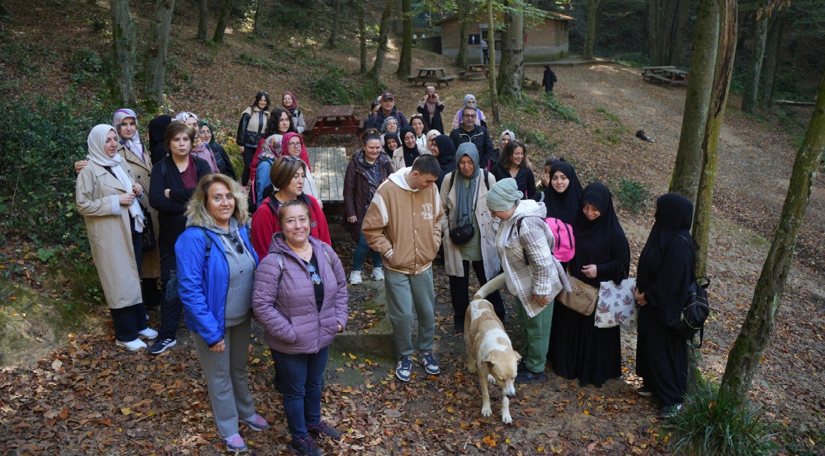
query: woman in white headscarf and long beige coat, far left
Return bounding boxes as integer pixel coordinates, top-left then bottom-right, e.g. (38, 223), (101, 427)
(75, 125), (157, 351)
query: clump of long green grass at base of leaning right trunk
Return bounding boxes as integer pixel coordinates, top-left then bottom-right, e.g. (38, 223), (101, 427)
(663, 383), (776, 456)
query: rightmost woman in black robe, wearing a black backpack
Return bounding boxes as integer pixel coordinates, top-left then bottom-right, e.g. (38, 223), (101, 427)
(636, 193), (694, 415)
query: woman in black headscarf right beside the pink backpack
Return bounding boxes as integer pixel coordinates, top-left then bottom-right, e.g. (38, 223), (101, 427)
(536, 160), (584, 366)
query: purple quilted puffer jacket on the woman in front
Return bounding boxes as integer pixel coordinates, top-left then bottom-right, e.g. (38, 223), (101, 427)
(252, 233), (348, 355)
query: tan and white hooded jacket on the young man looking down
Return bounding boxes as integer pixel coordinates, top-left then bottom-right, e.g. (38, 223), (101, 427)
(361, 167), (444, 275)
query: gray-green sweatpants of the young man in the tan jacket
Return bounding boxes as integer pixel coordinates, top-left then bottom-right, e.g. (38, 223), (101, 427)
(384, 268), (435, 356)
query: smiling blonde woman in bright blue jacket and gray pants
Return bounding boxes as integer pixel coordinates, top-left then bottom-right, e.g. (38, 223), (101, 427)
(175, 174), (269, 451)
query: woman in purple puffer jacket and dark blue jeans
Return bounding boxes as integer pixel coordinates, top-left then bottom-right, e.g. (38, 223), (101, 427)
(252, 200), (348, 455)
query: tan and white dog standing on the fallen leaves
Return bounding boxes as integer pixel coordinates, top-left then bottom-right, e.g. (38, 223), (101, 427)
(464, 274), (521, 424)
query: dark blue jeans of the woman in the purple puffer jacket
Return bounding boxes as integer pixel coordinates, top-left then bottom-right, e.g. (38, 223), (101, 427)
(272, 347), (329, 439)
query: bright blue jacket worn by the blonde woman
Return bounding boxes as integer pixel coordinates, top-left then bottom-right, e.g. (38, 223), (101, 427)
(175, 226), (258, 347)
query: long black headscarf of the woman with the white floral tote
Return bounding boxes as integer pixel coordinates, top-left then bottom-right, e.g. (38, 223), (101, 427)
(570, 182), (630, 287)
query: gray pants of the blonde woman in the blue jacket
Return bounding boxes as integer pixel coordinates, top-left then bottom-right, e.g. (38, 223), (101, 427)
(192, 317), (255, 438)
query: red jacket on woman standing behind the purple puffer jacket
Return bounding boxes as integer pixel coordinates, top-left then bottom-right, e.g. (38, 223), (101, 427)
(251, 194), (332, 260)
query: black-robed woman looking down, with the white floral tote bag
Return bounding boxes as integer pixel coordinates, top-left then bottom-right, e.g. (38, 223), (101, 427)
(553, 182), (630, 387)
